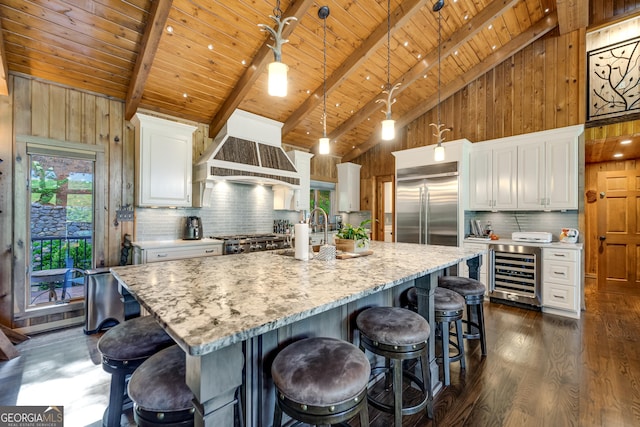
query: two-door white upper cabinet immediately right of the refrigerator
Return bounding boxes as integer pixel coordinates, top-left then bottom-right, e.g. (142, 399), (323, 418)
(468, 143), (518, 211)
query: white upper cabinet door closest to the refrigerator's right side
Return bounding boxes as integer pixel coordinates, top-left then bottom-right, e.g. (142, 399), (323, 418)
(468, 150), (493, 211)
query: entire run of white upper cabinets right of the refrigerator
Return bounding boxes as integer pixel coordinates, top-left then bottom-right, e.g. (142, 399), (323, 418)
(468, 125), (584, 211)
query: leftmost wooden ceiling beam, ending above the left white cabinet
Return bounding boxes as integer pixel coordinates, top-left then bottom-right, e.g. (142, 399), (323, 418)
(124, 0), (173, 120)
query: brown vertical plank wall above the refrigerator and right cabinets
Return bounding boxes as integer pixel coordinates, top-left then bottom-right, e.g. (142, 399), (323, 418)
(353, 29), (586, 241)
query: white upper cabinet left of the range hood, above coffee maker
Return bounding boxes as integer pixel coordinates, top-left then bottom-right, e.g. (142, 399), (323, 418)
(131, 114), (196, 207)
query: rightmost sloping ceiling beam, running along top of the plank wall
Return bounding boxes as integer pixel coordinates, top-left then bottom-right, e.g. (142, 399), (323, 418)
(342, 12), (558, 162)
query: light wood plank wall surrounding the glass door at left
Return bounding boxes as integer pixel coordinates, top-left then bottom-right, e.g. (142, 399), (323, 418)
(0, 75), (134, 327)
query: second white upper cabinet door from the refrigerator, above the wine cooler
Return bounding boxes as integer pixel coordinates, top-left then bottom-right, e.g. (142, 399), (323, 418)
(492, 146), (518, 209)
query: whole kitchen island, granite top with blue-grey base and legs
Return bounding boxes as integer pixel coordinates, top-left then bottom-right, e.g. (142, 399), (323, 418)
(111, 242), (482, 426)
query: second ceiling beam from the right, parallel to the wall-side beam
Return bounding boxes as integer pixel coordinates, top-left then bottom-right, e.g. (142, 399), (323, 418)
(312, 0), (519, 155)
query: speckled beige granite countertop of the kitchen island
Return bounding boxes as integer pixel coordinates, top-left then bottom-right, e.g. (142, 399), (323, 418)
(111, 242), (483, 355)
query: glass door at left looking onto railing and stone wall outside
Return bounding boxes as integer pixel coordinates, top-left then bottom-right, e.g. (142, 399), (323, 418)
(26, 153), (95, 308)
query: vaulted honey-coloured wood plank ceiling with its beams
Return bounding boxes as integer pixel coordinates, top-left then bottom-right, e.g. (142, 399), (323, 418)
(0, 0), (588, 161)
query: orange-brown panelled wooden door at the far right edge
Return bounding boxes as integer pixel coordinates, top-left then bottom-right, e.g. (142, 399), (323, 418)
(598, 170), (640, 295)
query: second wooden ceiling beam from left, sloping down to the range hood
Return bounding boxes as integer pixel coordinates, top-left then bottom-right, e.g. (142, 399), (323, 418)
(209, 0), (315, 138)
